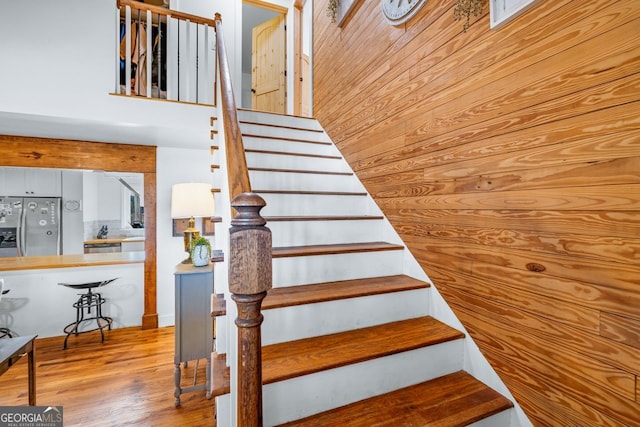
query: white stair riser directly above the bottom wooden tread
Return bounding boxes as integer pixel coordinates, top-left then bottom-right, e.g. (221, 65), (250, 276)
(263, 340), (463, 426)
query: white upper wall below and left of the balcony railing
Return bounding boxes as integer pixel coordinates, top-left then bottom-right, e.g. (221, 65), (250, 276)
(0, 0), (213, 148)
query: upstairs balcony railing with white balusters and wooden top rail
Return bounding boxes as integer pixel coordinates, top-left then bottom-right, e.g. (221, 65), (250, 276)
(115, 0), (217, 105)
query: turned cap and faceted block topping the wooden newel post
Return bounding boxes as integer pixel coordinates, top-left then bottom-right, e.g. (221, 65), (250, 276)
(229, 193), (272, 295)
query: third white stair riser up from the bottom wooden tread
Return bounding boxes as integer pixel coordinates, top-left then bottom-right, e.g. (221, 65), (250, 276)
(273, 250), (403, 287)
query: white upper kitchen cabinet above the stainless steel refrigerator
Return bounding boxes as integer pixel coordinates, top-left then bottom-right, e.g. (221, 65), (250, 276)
(0, 167), (62, 197)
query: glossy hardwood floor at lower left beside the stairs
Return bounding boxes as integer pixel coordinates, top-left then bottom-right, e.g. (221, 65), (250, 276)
(0, 327), (216, 427)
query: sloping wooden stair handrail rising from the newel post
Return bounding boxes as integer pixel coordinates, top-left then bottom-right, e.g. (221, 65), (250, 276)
(215, 13), (251, 200)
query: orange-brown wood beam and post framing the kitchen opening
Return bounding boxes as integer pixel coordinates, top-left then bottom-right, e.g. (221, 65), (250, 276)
(0, 135), (158, 329)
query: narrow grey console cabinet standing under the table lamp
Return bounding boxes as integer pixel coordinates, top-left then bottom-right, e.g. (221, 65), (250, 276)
(174, 263), (213, 406)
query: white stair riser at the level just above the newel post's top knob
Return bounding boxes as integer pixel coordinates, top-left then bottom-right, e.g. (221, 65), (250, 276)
(249, 171), (363, 192)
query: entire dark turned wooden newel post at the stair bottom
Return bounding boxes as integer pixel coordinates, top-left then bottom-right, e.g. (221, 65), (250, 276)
(229, 193), (271, 427)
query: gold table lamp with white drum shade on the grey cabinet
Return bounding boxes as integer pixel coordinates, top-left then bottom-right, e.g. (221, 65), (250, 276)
(171, 182), (214, 264)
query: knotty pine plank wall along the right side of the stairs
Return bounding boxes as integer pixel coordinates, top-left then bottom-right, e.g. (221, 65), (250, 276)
(313, 0), (640, 426)
